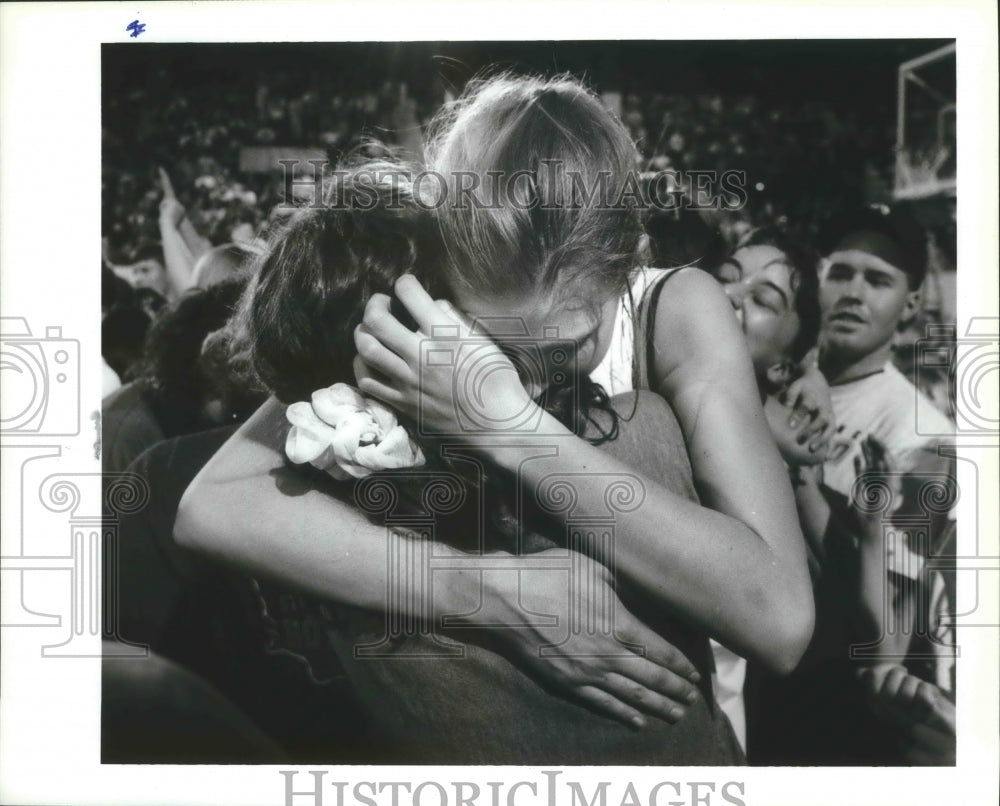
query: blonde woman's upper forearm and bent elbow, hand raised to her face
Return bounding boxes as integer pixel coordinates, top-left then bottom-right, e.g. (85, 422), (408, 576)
(488, 414), (813, 670)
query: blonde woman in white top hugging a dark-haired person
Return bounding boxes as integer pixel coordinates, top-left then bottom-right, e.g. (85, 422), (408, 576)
(176, 72), (812, 763)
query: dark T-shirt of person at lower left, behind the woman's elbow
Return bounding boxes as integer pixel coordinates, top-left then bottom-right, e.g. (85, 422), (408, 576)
(113, 426), (364, 763)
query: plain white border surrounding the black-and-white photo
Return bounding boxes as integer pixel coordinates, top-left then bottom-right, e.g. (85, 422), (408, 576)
(0, 0), (1000, 806)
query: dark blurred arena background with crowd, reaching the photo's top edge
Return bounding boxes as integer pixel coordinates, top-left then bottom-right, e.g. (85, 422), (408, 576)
(102, 40), (955, 410)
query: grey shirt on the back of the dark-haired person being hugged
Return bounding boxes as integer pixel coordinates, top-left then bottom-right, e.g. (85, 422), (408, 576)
(254, 393), (744, 766)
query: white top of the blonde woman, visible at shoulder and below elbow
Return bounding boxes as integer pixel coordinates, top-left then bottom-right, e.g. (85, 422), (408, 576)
(590, 269), (747, 752)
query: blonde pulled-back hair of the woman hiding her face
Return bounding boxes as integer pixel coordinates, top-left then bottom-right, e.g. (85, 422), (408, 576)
(426, 74), (642, 304)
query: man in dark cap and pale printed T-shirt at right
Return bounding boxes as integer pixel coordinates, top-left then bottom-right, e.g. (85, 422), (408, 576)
(820, 207), (954, 495)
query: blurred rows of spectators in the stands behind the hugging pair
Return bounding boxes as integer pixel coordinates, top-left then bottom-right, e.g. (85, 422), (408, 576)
(102, 60), (955, 420)
